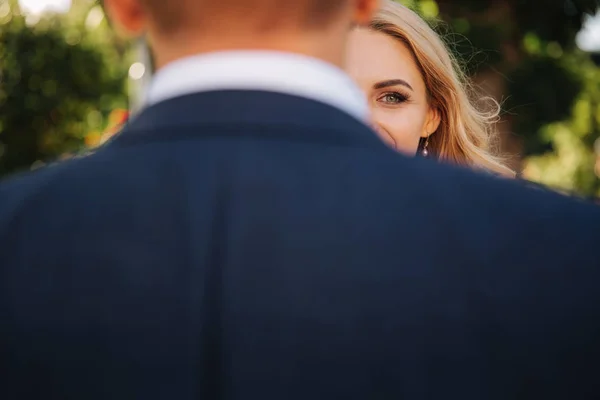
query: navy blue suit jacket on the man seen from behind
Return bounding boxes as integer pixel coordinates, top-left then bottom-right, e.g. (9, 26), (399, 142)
(0, 91), (600, 400)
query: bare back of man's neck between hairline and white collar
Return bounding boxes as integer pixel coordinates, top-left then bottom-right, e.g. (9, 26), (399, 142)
(152, 34), (345, 69)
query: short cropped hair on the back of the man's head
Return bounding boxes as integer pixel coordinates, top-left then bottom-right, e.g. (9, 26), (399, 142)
(140, 0), (349, 32)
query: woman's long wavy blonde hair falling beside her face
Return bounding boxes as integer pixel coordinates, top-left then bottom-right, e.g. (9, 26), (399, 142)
(370, 0), (515, 177)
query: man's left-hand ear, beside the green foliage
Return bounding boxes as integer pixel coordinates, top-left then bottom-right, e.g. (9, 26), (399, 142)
(104, 0), (147, 36)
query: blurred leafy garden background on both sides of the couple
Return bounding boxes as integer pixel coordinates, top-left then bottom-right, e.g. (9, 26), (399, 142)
(0, 0), (600, 198)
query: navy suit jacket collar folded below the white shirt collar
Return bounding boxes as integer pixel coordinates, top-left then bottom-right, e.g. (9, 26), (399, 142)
(111, 90), (385, 149)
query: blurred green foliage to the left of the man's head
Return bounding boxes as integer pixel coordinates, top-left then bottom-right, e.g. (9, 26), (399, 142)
(0, 0), (128, 176)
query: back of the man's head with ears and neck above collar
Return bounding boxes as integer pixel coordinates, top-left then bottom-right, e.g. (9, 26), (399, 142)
(105, 0), (379, 66)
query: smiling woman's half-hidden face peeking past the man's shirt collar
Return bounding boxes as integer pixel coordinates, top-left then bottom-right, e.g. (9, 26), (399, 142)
(346, 28), (439, 154)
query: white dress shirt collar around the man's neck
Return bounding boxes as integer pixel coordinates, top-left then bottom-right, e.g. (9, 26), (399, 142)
(146, 51), (369, 122)
